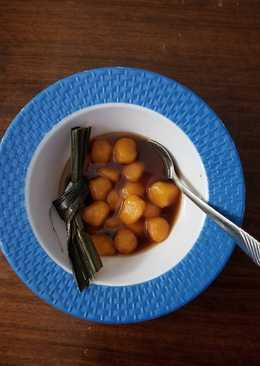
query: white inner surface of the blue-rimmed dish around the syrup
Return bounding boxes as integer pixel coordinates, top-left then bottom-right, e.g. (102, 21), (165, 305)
(26, 103), (208, 286)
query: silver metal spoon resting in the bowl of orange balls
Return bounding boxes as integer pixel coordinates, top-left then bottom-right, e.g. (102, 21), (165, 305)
(149, 140), (260, 266)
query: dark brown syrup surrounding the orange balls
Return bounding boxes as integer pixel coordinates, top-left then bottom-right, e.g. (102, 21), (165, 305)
(60, 132), (181, 253)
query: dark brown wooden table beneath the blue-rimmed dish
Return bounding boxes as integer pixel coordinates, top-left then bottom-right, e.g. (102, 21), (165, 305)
(0, 0), (260, 366)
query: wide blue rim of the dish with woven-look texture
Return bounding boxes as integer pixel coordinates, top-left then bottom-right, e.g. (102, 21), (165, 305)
(0, 67), (245, 323)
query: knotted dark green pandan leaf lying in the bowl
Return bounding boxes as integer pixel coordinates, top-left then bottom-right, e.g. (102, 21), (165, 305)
(53, 127), (102, 291)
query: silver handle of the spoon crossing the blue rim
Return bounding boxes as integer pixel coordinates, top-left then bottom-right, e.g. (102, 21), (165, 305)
(178, 178), (260, 266)
